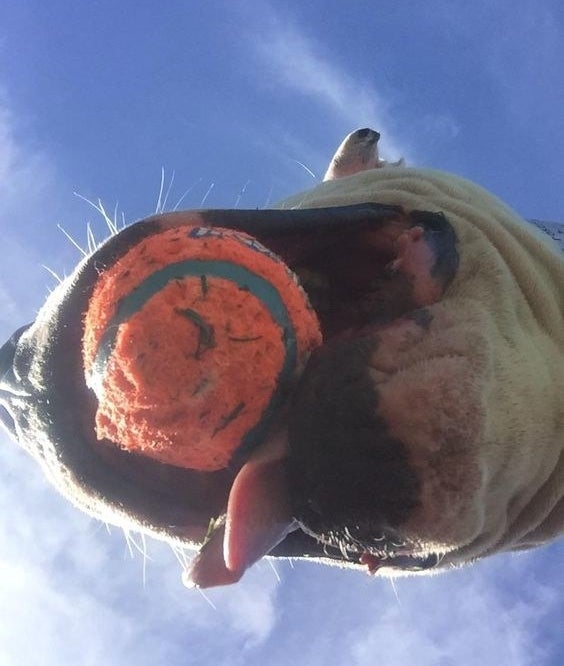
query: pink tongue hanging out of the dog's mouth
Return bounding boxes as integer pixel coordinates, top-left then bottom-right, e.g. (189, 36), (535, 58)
(185, 433), (296, 587)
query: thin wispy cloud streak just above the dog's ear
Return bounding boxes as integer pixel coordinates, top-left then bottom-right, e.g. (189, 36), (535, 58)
(227, 2), (412, 171)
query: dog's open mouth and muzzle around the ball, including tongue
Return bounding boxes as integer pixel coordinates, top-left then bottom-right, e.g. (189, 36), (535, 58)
(0, 204), (458, 586)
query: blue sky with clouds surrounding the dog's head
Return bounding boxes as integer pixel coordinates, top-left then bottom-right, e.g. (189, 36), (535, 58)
(0, 0), (564, 666)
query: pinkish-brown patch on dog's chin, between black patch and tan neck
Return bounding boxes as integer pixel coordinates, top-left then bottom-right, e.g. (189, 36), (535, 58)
(373, 312), (487, 551)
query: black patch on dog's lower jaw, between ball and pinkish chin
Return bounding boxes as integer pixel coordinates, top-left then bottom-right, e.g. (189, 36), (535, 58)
(288, 336), (420, 540)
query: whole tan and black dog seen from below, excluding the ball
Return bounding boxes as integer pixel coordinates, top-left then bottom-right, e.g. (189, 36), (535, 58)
(0, 129), (564, 587)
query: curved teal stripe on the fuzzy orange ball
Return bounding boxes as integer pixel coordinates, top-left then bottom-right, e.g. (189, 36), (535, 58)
(87, 259), (297, 465)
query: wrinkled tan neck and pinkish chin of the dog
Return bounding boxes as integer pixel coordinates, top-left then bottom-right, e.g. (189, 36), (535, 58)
(281, 168), (564, 563)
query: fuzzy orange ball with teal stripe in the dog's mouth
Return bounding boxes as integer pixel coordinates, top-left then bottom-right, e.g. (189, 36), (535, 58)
(83, 226), (321, 471)
